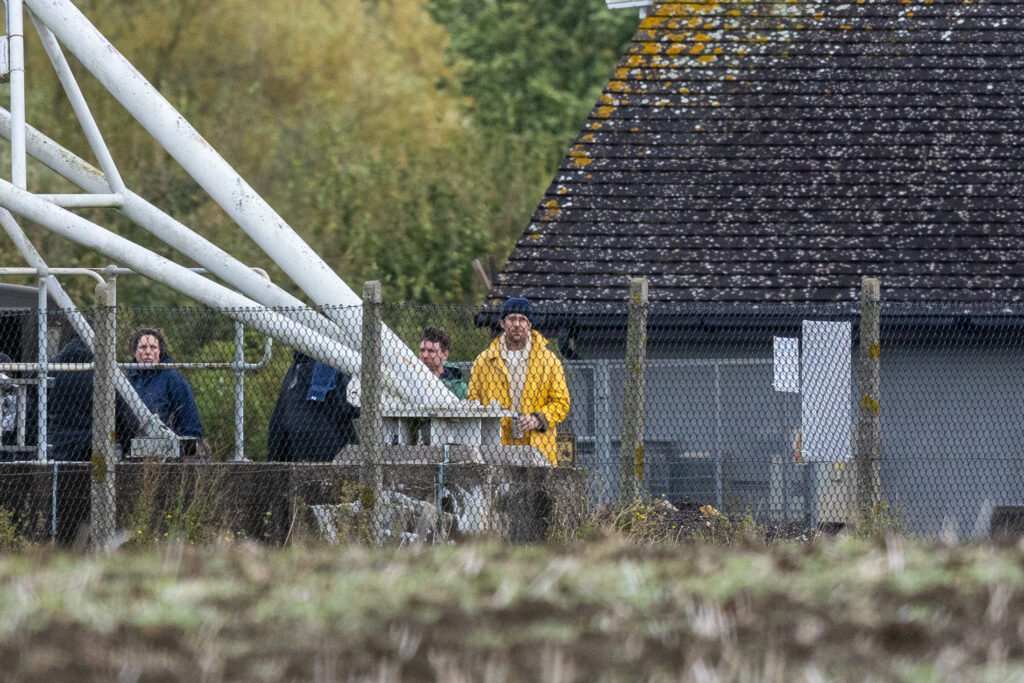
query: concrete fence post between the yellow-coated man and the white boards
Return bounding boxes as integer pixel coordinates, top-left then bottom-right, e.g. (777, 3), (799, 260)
(618, 278), (647, 503)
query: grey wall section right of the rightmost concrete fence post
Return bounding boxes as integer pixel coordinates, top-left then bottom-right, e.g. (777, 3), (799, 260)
(881, 346), (1024, 538)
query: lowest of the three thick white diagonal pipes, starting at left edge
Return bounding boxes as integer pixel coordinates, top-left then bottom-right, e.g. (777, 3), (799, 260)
(0, 179), (416, 402)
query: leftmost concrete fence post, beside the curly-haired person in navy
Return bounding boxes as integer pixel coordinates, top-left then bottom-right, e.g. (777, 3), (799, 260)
(89, 283), (117, 550)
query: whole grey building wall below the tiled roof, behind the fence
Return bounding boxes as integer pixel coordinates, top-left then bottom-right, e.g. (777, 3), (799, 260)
(566, 339), (1024, 538)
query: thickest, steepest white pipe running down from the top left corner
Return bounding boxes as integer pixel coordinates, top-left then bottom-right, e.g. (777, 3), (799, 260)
(26, 0), (458, 405)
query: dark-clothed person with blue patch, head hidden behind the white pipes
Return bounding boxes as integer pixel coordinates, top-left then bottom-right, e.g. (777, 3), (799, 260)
(267, 351), (359, 462)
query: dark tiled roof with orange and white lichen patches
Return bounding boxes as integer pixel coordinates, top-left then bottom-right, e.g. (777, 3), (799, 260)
(489, 0), (1024, 306)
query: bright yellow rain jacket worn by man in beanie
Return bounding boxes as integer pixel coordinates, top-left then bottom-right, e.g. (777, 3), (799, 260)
(469, 330), (569, 465)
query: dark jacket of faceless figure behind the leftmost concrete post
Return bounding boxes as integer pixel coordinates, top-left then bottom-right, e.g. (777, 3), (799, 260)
(46, 336), (135, 462)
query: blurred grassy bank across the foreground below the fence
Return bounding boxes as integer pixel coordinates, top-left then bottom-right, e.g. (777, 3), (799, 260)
(0, 540), (1024, 681)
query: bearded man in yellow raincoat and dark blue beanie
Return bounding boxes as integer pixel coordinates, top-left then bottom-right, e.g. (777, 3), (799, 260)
(468, 297), (569, 465)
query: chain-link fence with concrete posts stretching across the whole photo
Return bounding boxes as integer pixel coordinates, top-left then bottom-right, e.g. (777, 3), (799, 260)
(0, 290), (1024, 544)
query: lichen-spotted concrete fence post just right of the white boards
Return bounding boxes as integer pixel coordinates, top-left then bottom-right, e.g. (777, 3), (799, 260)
(857, 278), (882, 521)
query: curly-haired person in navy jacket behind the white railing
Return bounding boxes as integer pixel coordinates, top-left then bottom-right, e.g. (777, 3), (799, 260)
(128, 328), (203, 439)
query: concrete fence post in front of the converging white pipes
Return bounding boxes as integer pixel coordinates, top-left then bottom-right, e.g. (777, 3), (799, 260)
(359, 281), (386, 543)
